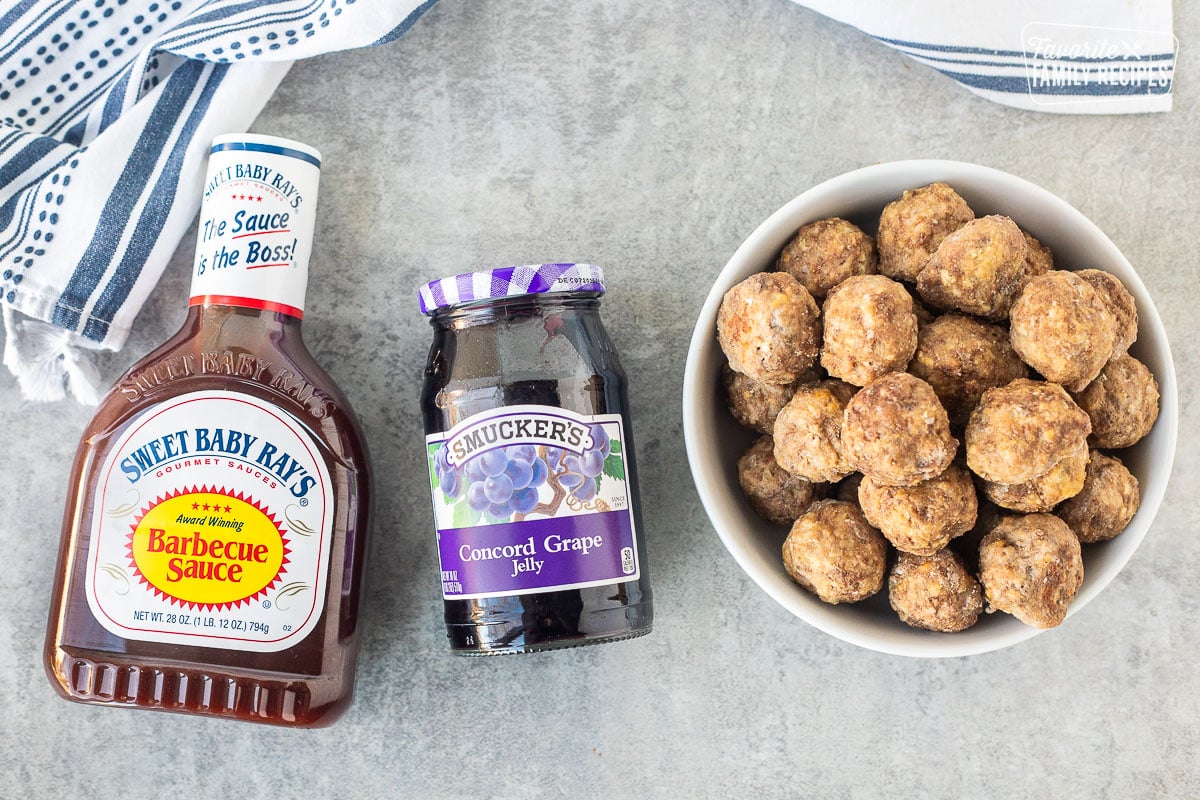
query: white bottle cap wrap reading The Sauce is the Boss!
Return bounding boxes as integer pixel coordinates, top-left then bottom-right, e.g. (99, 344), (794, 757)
(190, 133), (320, 317)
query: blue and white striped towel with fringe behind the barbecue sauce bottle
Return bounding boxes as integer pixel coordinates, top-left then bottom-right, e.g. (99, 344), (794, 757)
(0, 0), (434, 403)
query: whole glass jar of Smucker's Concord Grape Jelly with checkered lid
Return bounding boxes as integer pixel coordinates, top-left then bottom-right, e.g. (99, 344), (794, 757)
(420, 264), (654, 655)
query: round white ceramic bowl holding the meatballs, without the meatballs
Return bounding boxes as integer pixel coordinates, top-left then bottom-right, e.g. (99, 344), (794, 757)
(683, 161), (1178, 657)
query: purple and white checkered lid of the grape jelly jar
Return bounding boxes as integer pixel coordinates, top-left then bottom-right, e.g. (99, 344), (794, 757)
(419, 264), (605, 314)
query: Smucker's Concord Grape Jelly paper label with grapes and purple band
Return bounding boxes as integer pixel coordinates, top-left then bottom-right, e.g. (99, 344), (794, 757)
(426, 405), (641, 600)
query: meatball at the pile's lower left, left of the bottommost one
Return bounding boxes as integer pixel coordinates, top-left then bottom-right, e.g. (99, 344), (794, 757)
(784, 500), (888, 603)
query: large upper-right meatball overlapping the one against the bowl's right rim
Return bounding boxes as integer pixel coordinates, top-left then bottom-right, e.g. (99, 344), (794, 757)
(1009, 270), (1117, 391)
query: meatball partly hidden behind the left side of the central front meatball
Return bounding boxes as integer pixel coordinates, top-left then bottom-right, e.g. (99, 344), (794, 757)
(774, 380), (854, 483)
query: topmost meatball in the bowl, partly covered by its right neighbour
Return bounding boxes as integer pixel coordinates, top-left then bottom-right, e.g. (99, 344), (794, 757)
(877, 184), (974, 281)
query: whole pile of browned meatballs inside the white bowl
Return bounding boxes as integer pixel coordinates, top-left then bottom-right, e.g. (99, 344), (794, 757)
(716, 184), (1158, 632)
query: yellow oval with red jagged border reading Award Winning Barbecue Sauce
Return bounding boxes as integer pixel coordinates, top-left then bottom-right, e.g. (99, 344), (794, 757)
(128, 487), (289, 608)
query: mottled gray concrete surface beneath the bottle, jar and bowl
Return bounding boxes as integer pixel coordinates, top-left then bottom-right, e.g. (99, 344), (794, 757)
(0, 0), (1200, 799)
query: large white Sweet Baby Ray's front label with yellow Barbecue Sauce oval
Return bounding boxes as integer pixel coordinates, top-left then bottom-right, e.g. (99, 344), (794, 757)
(86, 391), (332, 652)
